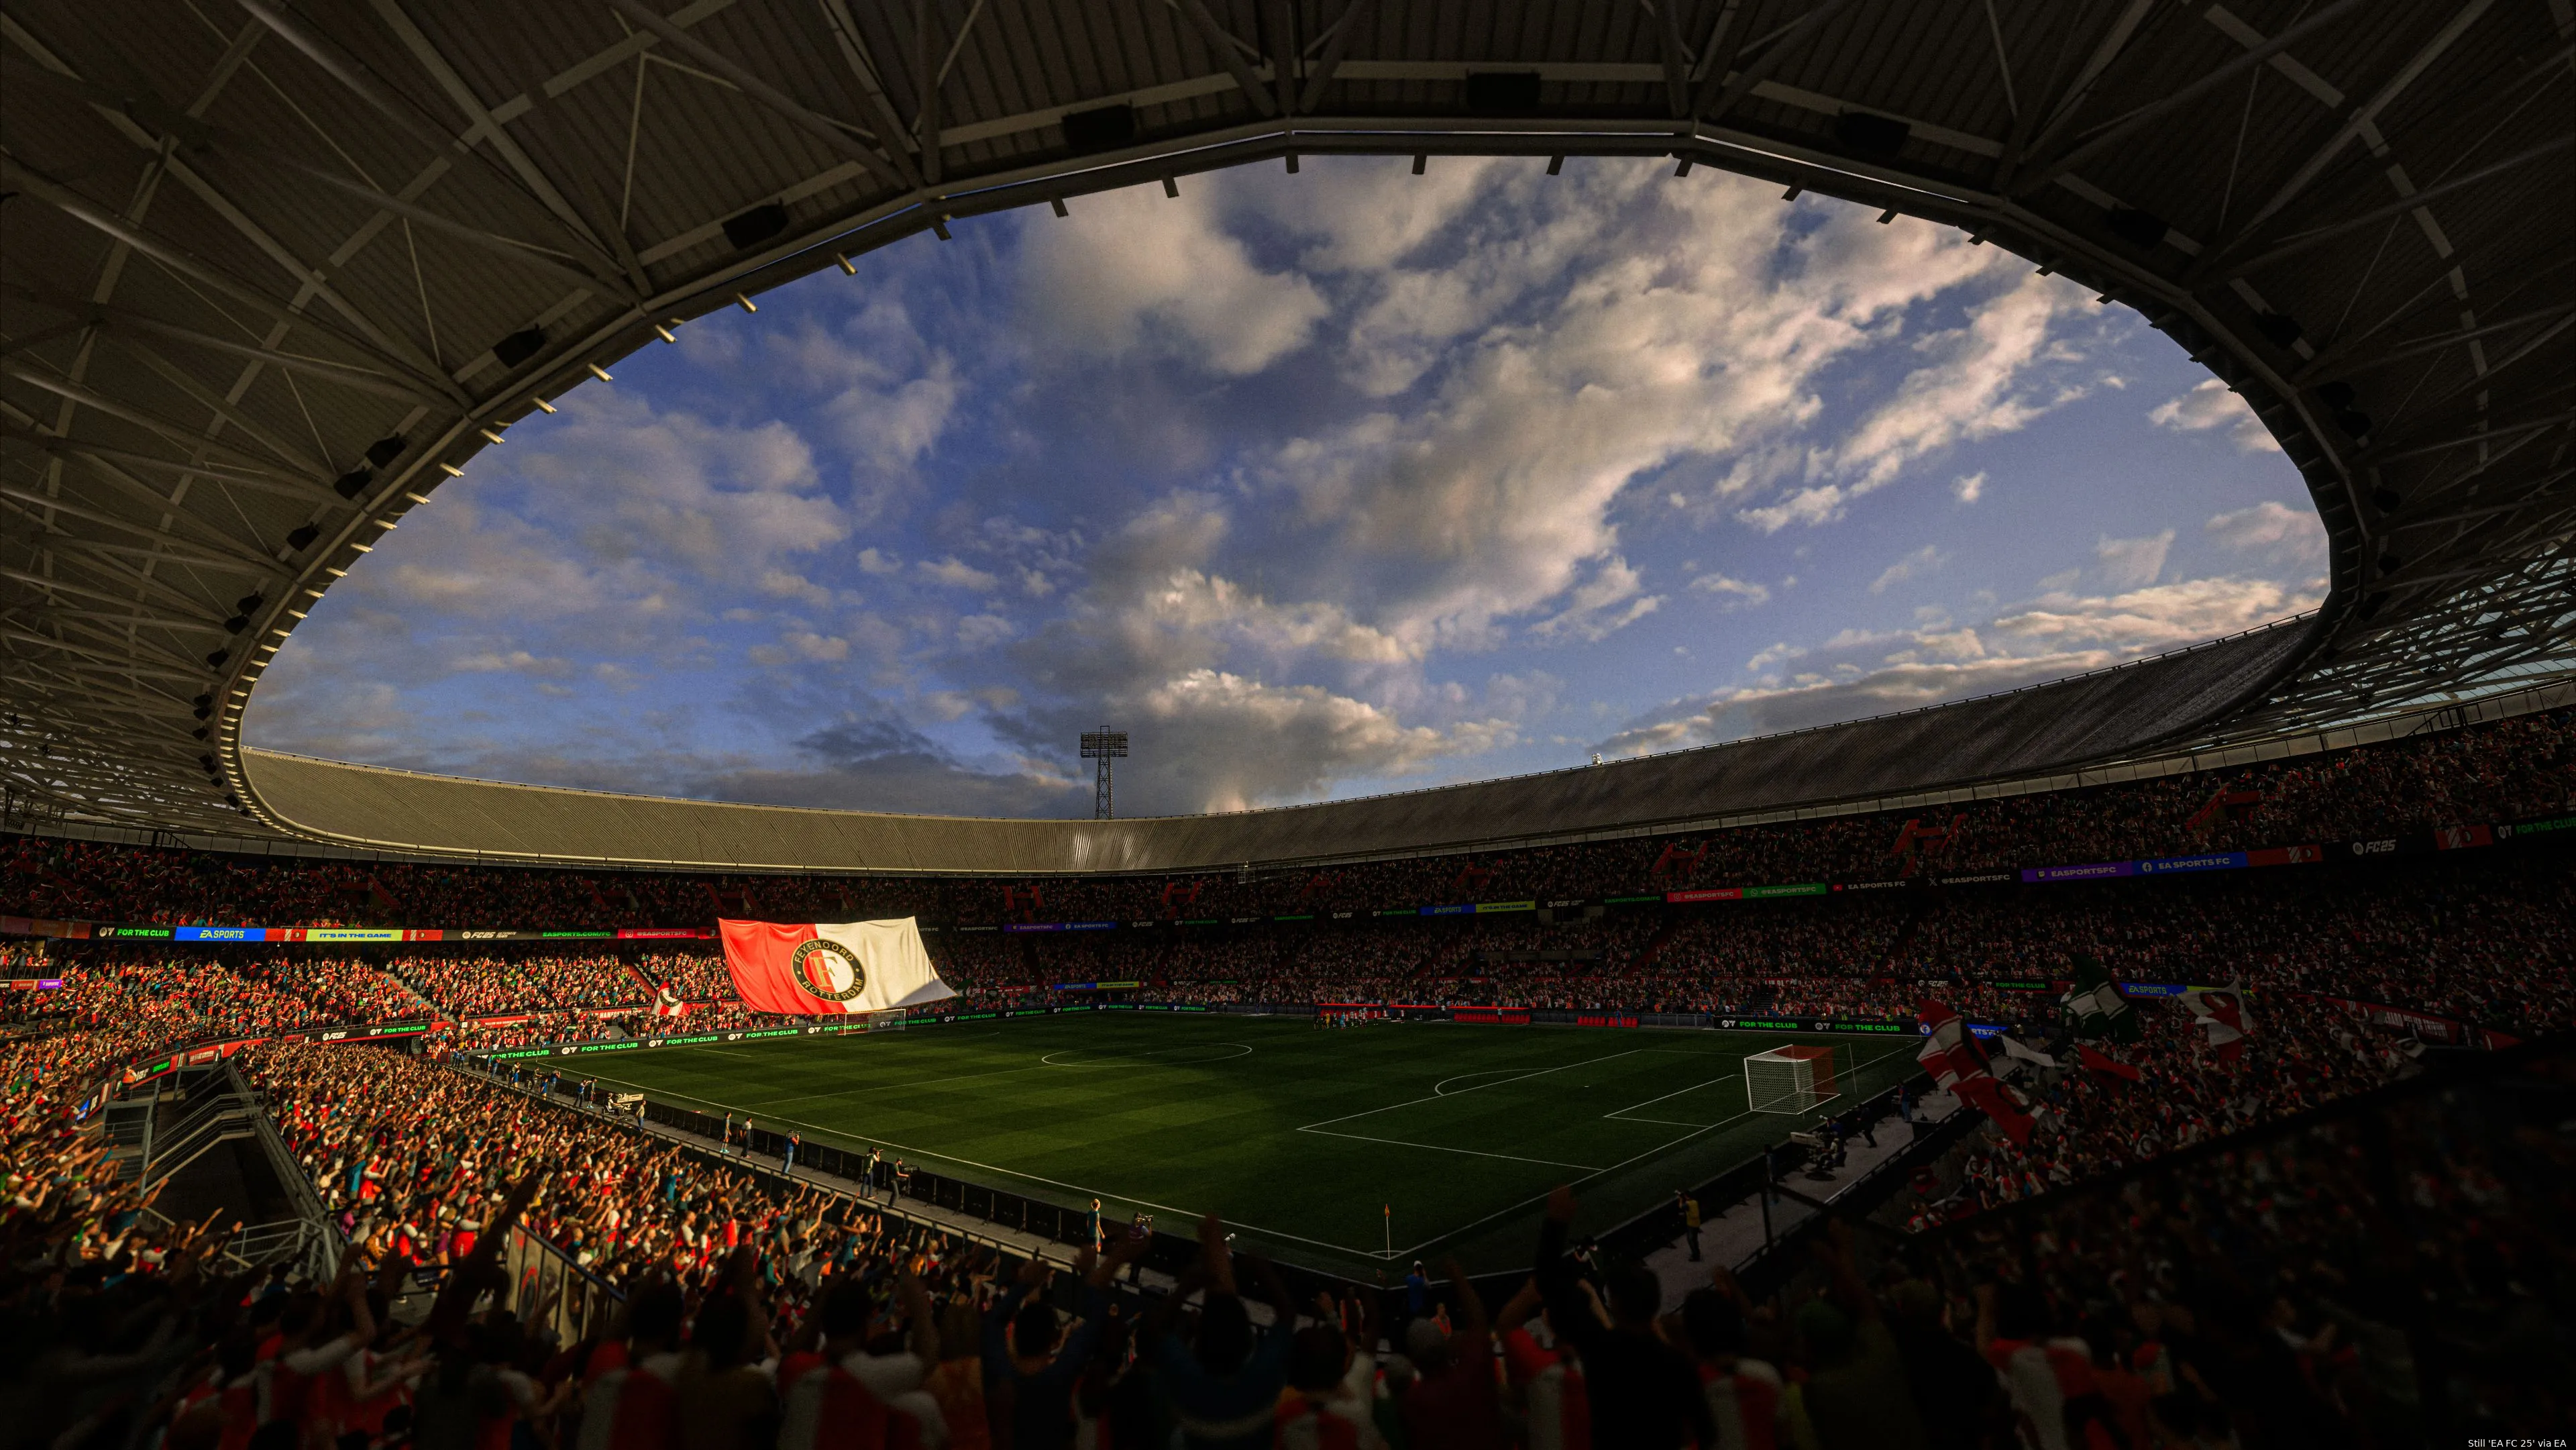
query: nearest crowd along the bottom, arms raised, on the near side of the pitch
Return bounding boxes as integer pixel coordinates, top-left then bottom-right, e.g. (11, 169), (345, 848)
(15, 1020), (2576, 1450)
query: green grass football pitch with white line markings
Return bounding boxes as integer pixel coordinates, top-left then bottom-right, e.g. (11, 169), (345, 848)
(549, 1015), (1919, 1275)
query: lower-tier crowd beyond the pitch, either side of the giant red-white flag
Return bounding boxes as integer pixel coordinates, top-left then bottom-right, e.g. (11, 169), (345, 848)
(0, 834), (2576, 1082)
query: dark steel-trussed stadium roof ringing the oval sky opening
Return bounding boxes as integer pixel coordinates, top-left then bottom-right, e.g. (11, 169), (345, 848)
(0, 0), (2576, 870)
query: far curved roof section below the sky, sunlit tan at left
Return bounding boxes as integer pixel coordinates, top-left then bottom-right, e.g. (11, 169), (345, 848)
(242, 615), (2318, 876)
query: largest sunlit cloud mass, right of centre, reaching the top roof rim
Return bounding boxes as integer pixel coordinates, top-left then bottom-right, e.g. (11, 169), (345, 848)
(1275, 165), (2058, 649)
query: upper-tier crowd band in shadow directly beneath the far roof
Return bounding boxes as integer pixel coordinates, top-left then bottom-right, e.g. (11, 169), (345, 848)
(0, 711), (2576, 927)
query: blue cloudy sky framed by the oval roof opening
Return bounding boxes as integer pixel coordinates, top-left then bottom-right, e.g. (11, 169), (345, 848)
(248, 157), (2324, 817)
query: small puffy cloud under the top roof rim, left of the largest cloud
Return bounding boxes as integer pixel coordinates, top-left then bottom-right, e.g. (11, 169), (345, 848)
(1020, 185), (1329, 376)
